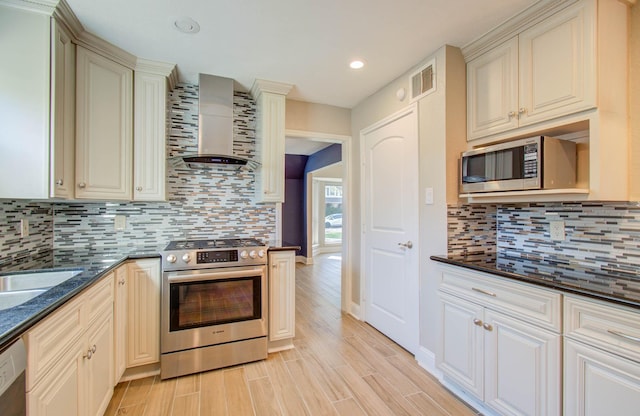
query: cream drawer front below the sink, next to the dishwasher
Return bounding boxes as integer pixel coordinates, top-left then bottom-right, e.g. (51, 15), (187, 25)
(24, 299), (84, 391)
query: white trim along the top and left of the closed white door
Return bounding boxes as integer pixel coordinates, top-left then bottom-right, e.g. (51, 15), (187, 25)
(360, 102), (420, 322)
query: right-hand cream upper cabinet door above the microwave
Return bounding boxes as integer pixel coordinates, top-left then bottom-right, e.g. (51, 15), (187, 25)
(519, 1), (597, 126)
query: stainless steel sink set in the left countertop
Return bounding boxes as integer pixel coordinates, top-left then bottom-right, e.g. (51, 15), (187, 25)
(0, 269), (82, 310)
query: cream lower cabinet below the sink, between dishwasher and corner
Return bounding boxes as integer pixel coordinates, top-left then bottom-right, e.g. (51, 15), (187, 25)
(24, 274), (114, 416)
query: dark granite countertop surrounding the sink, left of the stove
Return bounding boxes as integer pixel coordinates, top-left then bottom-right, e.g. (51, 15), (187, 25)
(0, 246), (161, 350)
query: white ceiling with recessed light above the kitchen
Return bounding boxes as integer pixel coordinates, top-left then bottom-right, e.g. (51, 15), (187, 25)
(67, 0), (535, 108)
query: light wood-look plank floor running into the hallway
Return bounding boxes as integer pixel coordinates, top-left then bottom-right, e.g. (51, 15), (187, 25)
(105, 255), (476, 416)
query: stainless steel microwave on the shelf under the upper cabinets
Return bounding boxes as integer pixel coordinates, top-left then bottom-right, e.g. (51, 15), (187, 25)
(460, 136), (576, 193)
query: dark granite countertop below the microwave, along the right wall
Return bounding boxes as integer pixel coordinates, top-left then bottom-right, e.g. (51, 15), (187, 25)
(431, 253), (640, 309)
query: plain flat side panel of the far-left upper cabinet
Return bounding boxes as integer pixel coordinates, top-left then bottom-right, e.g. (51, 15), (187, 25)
(0, 4), (51, 199)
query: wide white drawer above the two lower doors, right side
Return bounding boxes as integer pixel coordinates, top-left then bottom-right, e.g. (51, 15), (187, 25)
(440, 266), (562, 332)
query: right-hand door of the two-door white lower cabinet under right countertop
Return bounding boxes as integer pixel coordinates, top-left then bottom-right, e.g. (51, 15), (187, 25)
(483, 310), (561, 415)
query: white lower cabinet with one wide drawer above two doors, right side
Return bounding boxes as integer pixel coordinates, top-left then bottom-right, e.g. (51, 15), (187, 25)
(436, 267), (562, 415)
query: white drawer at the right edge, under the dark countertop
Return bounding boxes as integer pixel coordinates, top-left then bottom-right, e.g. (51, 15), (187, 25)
(564, 295), (640, 362)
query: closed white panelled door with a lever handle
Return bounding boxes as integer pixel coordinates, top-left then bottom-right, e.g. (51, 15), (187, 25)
(361, 106), (419, 353)
